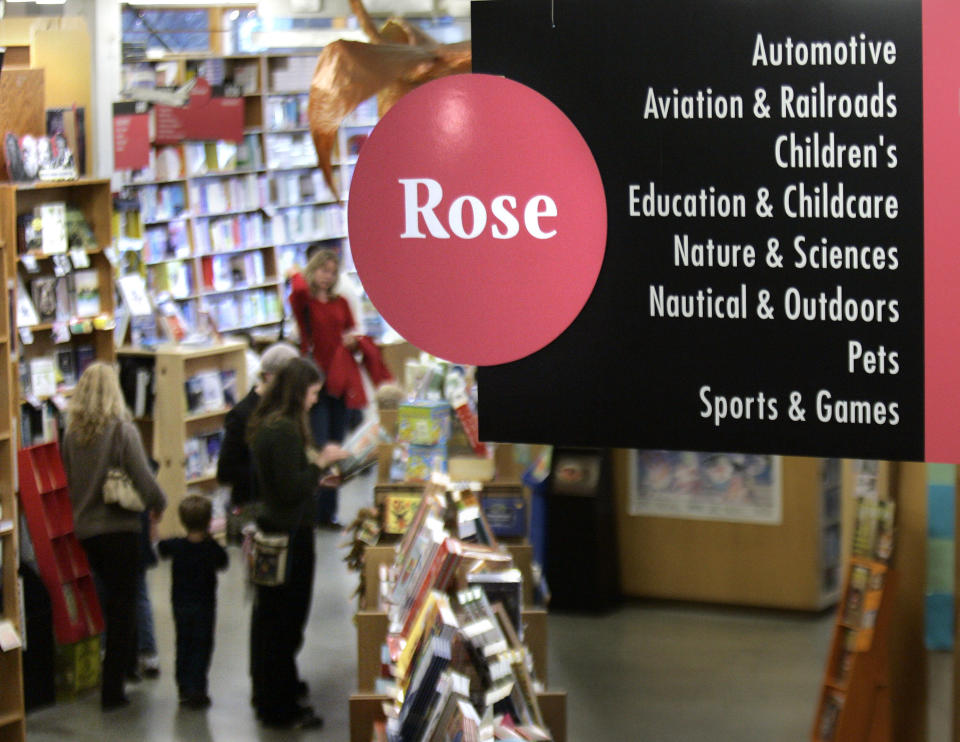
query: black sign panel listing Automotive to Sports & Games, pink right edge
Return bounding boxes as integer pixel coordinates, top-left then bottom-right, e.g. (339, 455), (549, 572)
(458, 0), (960, 462)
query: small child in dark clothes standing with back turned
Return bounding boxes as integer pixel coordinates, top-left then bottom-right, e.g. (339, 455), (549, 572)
(157, 495), (227, 708)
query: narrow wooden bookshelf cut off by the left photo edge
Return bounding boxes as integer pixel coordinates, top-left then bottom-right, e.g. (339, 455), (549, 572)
(0, 239), (27, 742)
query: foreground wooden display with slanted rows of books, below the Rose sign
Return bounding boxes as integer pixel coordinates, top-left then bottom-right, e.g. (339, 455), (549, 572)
(350, 476), (566, 742)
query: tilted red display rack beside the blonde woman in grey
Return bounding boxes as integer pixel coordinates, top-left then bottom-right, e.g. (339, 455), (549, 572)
(17, 442), (103, 644)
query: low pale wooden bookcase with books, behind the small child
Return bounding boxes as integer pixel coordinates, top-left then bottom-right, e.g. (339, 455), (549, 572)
(117, 342), (247, 538)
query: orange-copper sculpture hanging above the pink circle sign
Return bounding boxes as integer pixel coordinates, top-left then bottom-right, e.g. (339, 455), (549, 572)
(307, 0), (472, 197)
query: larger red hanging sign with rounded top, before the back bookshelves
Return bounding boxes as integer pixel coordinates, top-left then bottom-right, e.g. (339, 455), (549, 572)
(153, 77), (243, 144)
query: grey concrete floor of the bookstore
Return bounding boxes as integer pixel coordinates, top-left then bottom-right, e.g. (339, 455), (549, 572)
(27, 479), (951, 742)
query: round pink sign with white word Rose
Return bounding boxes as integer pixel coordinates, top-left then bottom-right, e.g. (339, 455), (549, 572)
(349, 75), (607, 366)
